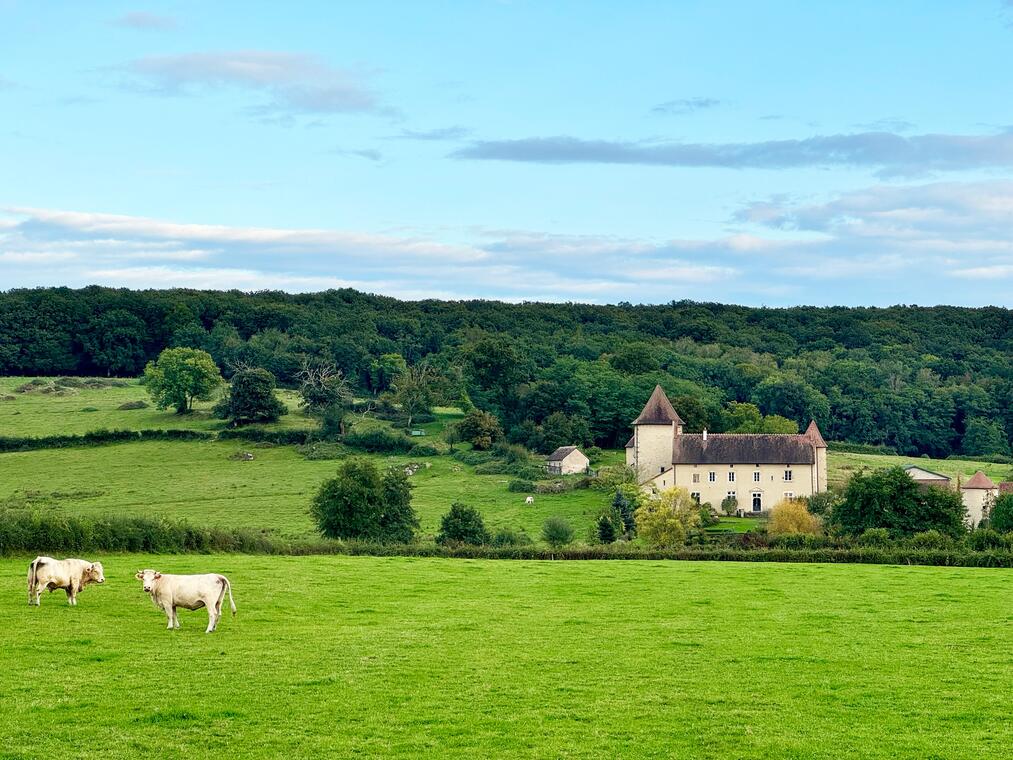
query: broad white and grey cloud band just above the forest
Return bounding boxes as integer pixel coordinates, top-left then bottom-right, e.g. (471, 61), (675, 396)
(9, 180), (1013, 305)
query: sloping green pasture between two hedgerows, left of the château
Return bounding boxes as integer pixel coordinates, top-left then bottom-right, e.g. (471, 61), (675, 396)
(0, 441), (608, 537)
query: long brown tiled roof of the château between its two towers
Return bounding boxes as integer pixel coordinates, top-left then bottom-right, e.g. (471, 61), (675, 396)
(672, 433), (822, 464)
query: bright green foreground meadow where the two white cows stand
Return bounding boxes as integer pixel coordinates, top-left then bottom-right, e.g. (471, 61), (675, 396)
(0, 555), (1013, 760)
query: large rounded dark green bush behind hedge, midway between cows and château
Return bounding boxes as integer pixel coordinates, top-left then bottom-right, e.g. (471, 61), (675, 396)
(310, 457), (418, 542)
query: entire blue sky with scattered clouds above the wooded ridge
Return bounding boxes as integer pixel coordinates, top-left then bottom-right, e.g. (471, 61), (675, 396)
(0, 0), (1013, 307)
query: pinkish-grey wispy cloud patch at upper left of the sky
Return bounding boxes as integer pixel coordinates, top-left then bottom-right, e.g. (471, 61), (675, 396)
(116, 50), (394, 116)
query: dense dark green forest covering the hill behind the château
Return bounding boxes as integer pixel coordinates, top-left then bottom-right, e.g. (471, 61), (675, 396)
(0, 288), (1013, 456)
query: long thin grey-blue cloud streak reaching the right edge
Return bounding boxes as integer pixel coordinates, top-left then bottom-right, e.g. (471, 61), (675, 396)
(451, 131), (1013, 176)
